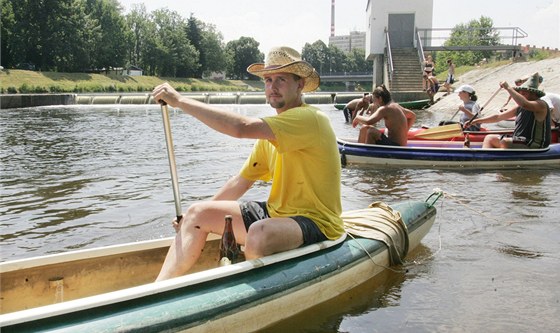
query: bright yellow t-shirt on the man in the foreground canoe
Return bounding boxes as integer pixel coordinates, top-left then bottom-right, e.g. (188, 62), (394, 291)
(241, 104), (344, 239)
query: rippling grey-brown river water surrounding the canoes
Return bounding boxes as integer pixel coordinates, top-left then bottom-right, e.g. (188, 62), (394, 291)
(0, 105), (560, 332)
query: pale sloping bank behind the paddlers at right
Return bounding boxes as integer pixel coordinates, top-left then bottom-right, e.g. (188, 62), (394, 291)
(428, 57), (560, 121)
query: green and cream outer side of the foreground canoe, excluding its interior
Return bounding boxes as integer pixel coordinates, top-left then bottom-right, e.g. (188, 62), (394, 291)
(0, 202), (436, 332)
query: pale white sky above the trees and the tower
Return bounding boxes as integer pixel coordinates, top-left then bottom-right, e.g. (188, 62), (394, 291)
(118, 0), (560, 54)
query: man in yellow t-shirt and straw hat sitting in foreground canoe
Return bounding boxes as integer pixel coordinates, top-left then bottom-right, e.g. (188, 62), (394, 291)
(153, 47), (344, 280)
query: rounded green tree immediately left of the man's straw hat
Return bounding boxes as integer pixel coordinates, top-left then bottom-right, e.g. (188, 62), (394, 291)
(226, 37), (264, 80)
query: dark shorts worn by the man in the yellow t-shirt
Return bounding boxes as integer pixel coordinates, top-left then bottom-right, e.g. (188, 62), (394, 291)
(239, 201), (327, 246)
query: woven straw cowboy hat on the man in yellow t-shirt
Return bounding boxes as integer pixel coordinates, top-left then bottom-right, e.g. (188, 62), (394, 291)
(247, 46), (321, 92)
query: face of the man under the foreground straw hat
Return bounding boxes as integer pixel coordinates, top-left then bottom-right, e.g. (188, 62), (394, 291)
(264, 73), (304, 111)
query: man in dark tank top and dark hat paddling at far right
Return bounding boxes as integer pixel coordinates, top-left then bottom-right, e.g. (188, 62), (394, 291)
(465, 73), (551, 149)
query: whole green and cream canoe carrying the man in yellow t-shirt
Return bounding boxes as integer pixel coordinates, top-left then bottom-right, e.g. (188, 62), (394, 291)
(0, 198), (441, 333)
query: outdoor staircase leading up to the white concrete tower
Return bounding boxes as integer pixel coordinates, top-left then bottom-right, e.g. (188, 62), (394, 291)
(390, 48), (422, 92)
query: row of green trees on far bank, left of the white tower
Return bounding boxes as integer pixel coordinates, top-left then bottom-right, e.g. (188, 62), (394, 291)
(0, 0), (371, 79)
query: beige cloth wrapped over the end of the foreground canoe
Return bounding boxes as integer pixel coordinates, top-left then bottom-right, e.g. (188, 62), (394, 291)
(341, 201), (409, 265)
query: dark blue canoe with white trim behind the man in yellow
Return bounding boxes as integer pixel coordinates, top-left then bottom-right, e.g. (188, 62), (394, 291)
(337, 138), (560, 168)
